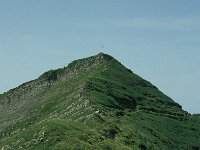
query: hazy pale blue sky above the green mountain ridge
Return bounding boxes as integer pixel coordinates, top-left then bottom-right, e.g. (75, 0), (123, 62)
(0, 0), (200, 113)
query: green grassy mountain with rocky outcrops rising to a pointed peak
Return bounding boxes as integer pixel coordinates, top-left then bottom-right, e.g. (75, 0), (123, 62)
(0, 53), (200, 150)
